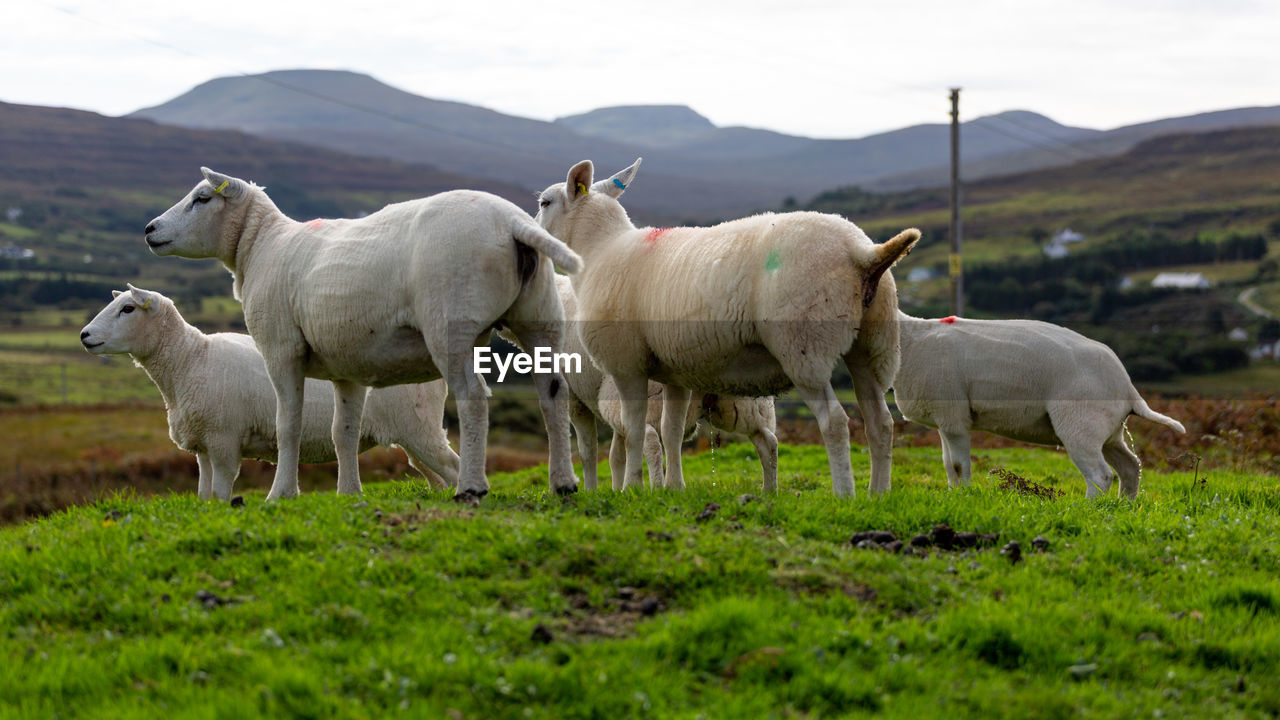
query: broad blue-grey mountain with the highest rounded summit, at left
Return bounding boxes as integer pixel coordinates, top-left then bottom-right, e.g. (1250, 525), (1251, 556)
(129, 70), (780, 221)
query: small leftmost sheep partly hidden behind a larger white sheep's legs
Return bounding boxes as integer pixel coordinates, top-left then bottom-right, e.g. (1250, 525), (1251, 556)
(81, 284), (458, 500)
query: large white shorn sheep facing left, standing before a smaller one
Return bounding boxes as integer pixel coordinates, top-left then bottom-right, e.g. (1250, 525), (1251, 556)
(145, 168), (581, 502)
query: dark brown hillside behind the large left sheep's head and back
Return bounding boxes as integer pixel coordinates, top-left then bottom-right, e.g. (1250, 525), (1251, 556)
(0, 102), (531, 299)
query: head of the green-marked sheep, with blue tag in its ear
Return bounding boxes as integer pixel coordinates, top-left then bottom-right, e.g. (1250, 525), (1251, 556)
(534, 158), (641, 251)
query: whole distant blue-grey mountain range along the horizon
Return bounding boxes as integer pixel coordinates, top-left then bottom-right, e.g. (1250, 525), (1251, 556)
(131, 70), (1280, 219)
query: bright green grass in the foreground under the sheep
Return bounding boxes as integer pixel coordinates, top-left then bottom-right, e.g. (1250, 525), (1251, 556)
(0, 446), (1280, 719)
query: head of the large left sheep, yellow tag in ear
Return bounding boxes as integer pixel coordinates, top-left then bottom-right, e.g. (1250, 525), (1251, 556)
(145, 168), (251, 261)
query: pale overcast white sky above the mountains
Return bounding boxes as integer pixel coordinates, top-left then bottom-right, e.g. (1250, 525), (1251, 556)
(0, 0), (1280, 137)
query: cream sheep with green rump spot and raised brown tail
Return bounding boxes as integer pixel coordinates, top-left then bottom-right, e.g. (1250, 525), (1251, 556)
(536, 159), (920, 496)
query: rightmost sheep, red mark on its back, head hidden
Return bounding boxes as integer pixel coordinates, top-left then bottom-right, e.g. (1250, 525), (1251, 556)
(893, 313), (1185, 498)
